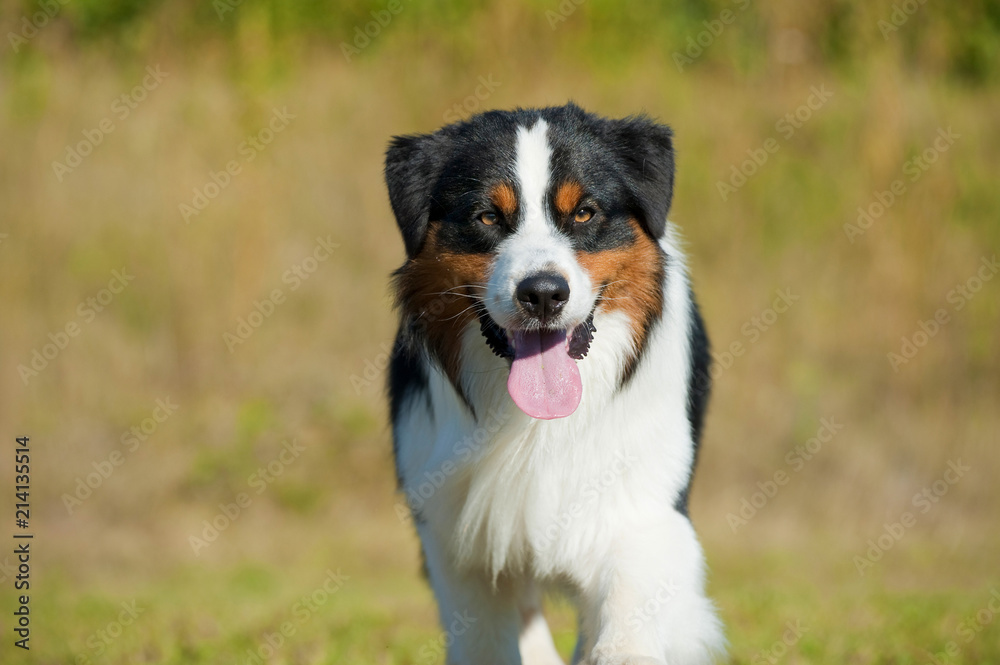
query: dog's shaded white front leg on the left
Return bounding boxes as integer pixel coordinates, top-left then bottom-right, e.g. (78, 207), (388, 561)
(417, 524), (521, 665)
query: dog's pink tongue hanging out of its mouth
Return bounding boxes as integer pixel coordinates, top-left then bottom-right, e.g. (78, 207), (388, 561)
(507, 330), (583, 420)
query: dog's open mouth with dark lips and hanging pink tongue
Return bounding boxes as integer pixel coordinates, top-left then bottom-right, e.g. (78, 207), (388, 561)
(479, 309), (597, 420)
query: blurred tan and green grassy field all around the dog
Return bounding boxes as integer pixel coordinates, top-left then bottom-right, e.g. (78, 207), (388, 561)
(0, 0), (1000, 665)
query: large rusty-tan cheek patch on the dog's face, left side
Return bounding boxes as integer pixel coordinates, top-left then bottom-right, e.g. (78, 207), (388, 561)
(395, 222), (493, 390)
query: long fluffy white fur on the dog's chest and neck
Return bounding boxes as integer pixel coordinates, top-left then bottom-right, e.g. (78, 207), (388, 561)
(397, 234), (693, 577)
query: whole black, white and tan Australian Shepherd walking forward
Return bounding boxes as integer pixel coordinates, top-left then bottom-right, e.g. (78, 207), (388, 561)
(385, 104), (724, 665)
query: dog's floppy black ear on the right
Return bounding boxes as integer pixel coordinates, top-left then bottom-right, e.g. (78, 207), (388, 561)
(609, 116), (674, 238)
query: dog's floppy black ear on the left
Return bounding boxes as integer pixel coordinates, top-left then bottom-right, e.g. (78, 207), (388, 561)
(385, 132), (450, 259)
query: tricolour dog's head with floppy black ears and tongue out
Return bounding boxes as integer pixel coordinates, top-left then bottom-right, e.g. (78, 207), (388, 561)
(385, 104), (674, 419)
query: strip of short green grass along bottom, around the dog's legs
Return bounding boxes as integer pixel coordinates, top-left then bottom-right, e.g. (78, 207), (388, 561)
(0, 543), (1000, 665)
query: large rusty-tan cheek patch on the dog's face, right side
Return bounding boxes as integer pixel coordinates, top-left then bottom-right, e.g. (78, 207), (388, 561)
(576, 220), (664, 372)
